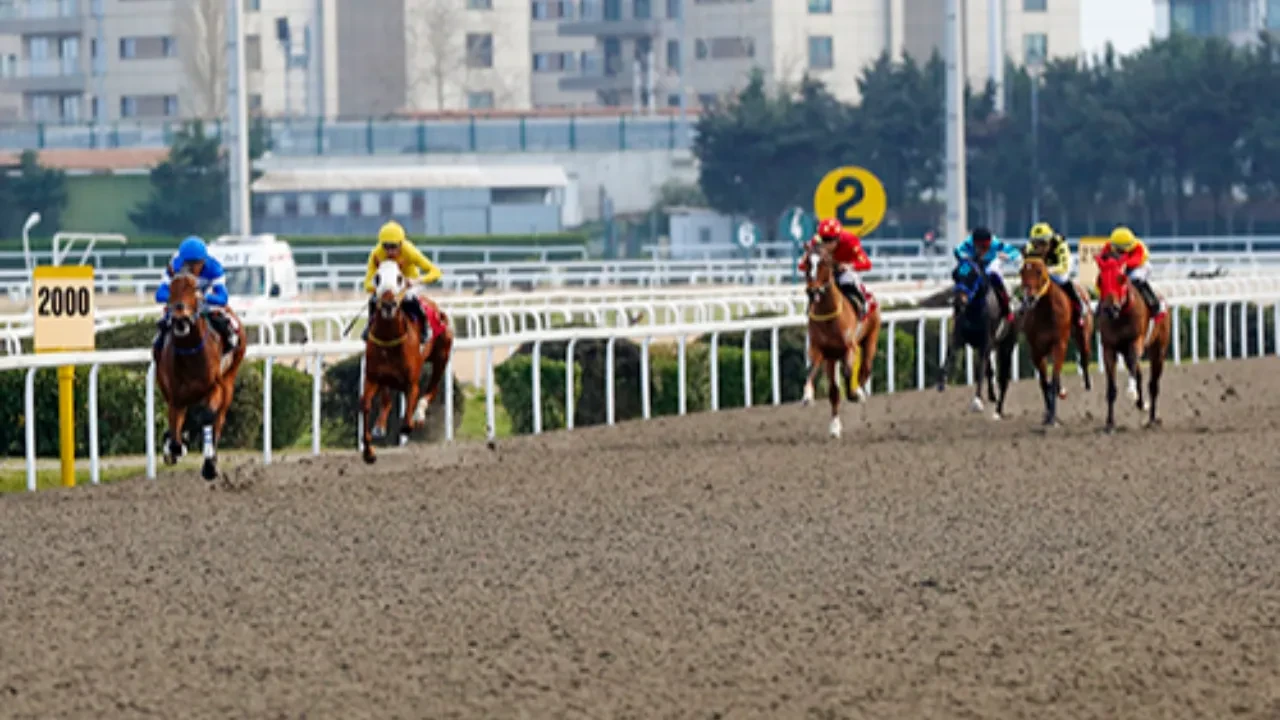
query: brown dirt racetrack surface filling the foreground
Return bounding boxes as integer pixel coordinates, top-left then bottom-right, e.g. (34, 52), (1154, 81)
(0, 360), (1280, 720)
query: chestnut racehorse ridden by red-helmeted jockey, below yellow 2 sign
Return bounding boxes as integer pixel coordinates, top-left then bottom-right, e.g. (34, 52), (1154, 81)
(804, 250), (881, 438)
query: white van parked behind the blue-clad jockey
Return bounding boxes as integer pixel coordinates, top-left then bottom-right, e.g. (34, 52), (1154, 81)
(209, 234), (298, 313)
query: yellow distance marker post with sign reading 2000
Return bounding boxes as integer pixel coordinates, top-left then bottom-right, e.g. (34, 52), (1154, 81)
(27, 265), (95, 487)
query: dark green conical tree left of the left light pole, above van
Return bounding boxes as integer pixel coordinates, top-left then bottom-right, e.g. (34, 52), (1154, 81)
(129, 120), (228, 236)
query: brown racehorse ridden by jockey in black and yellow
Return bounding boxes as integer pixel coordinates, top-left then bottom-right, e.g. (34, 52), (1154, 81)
(1019, 258), (1093, 425)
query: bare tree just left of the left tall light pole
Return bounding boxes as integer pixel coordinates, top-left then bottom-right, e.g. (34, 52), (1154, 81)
(173, 0), (227, 118)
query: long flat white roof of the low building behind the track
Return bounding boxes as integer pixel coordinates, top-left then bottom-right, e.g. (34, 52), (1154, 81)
(251, 165), (568, 192)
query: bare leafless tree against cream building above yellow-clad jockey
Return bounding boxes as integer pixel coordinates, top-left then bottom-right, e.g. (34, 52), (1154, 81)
(404, 0), (467, 110)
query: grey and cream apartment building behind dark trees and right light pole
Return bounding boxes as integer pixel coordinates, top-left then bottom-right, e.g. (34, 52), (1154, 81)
(531, 0), (1080, 106)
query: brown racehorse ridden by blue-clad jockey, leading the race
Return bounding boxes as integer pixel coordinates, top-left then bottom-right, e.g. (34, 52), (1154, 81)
(152, 272), (248, 480)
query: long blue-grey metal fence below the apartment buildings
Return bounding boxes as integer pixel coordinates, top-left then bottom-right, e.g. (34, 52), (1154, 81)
(0, 115), (694, 156)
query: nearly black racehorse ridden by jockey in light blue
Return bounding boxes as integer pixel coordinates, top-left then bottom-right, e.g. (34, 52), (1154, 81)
(937, 259), (1018, 420)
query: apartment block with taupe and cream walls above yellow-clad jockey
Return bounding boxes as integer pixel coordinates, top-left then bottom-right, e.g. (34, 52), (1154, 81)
(329, 0), (532, 117)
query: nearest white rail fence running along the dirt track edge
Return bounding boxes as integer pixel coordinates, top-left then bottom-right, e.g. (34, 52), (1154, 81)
(0, 293), (1280, 491)
